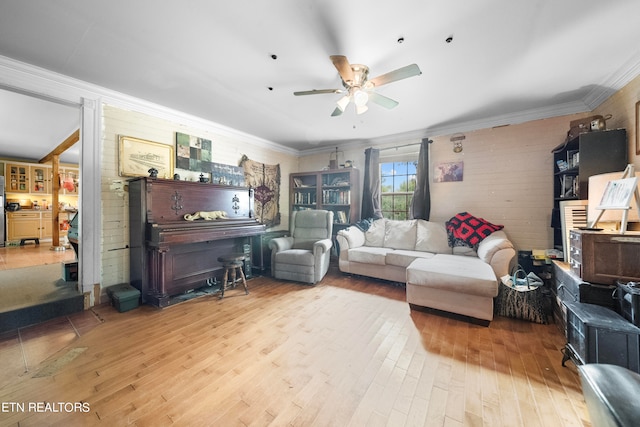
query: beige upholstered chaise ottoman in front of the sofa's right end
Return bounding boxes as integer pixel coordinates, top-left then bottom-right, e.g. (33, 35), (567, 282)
(407, 254), (498, 326)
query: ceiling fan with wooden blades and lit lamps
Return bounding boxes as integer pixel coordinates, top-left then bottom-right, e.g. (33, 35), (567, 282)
(293, 55), (422, 117)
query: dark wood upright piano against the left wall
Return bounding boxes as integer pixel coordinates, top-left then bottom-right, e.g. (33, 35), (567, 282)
(129, 177), (265, 307)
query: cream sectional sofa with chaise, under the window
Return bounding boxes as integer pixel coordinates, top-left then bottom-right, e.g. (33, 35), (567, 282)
(337, 219), (516, 324)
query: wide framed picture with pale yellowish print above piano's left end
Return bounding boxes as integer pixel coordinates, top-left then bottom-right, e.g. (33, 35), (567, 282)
(119, 136), (174, 178)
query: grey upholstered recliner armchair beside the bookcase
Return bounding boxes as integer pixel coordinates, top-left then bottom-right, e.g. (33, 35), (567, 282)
(269, 210), (333, 284)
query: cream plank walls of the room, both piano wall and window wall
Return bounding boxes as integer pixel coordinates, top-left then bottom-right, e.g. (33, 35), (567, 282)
(101, 76), (640, 294)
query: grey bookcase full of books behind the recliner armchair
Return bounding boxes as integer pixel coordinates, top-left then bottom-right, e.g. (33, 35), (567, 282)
(289, 168), (360, 227)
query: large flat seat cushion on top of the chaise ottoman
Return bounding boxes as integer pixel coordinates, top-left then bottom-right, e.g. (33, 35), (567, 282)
(407, 254), (498, 298)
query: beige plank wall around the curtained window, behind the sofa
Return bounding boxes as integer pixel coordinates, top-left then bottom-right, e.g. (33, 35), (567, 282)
(300, 76), (640, 254)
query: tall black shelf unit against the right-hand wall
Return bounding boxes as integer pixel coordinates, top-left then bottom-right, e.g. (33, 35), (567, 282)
(551, 129), (628, 250)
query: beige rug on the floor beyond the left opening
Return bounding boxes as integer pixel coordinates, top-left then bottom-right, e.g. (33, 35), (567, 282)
(0, 263), (80, 312)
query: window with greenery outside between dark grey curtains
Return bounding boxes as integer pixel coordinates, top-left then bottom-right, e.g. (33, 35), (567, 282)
(380, 161), (418, 220)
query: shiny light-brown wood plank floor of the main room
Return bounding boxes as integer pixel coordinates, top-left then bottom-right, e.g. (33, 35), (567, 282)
(0, 268), (590, 427)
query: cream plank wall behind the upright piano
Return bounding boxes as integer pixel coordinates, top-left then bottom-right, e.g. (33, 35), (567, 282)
(101, 105), (297, 289)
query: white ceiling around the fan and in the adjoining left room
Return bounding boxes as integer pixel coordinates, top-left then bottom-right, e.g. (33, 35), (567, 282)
(0, 0), (640, 164)
